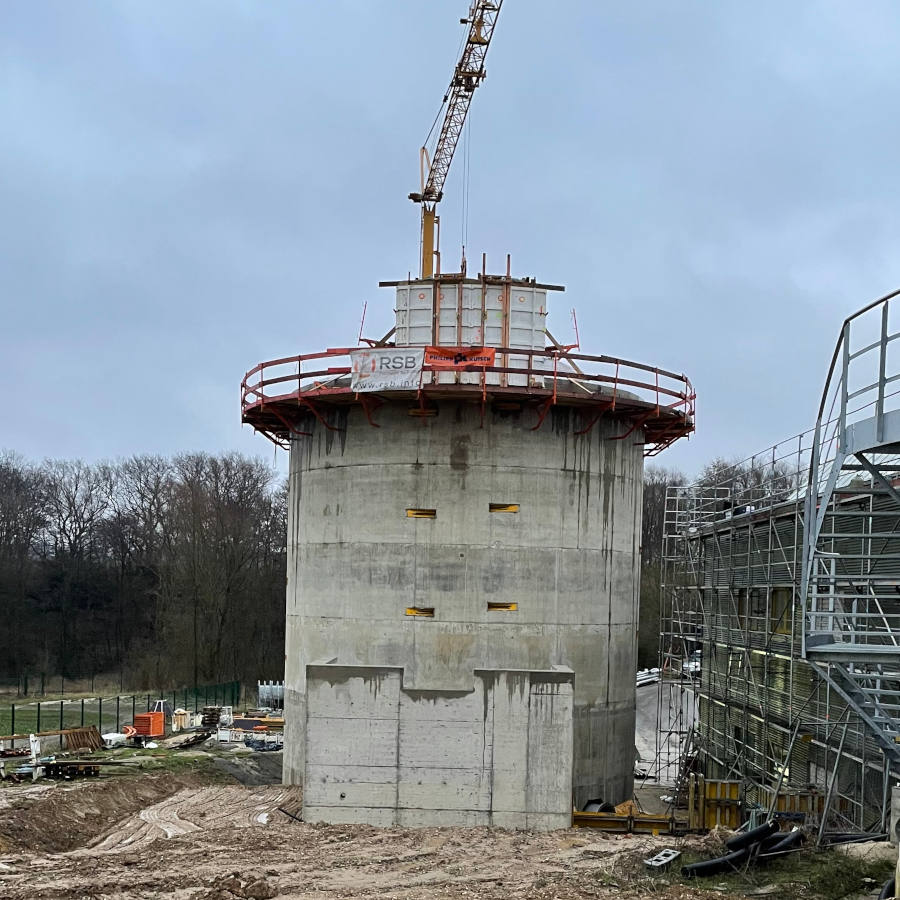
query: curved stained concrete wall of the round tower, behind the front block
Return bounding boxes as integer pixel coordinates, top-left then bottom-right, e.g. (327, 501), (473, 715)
(284, 402), (643, 803)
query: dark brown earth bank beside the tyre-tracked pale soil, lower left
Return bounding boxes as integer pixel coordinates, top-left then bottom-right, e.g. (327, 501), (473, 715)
(0, 774), (196, 853)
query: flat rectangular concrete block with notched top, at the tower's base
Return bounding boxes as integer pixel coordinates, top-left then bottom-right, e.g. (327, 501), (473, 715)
(303, 665), (572, 830)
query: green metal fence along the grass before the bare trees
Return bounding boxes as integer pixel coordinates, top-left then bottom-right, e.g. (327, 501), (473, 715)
(0, 681), (241, 738)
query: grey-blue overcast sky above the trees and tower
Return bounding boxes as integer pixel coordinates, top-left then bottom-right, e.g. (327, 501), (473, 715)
(0, 0), (900, 472)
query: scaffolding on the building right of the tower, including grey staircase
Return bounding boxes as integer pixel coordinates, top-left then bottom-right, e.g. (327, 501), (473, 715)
(658, 295), (900, 834)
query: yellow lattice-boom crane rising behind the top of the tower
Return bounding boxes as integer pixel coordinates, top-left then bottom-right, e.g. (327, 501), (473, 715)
(409, 0), (503, 278)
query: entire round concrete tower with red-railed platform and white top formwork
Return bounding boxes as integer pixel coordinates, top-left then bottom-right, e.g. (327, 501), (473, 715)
(243, 266), (693, 827)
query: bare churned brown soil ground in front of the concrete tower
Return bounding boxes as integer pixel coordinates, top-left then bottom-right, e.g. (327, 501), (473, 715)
(0, 750), (889, 900)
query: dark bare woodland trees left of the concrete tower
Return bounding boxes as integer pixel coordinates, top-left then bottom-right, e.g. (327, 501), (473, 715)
(0, 453), (287, 688)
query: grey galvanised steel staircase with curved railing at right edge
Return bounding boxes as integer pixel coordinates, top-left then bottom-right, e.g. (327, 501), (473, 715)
(801, 292), (900, 767)
